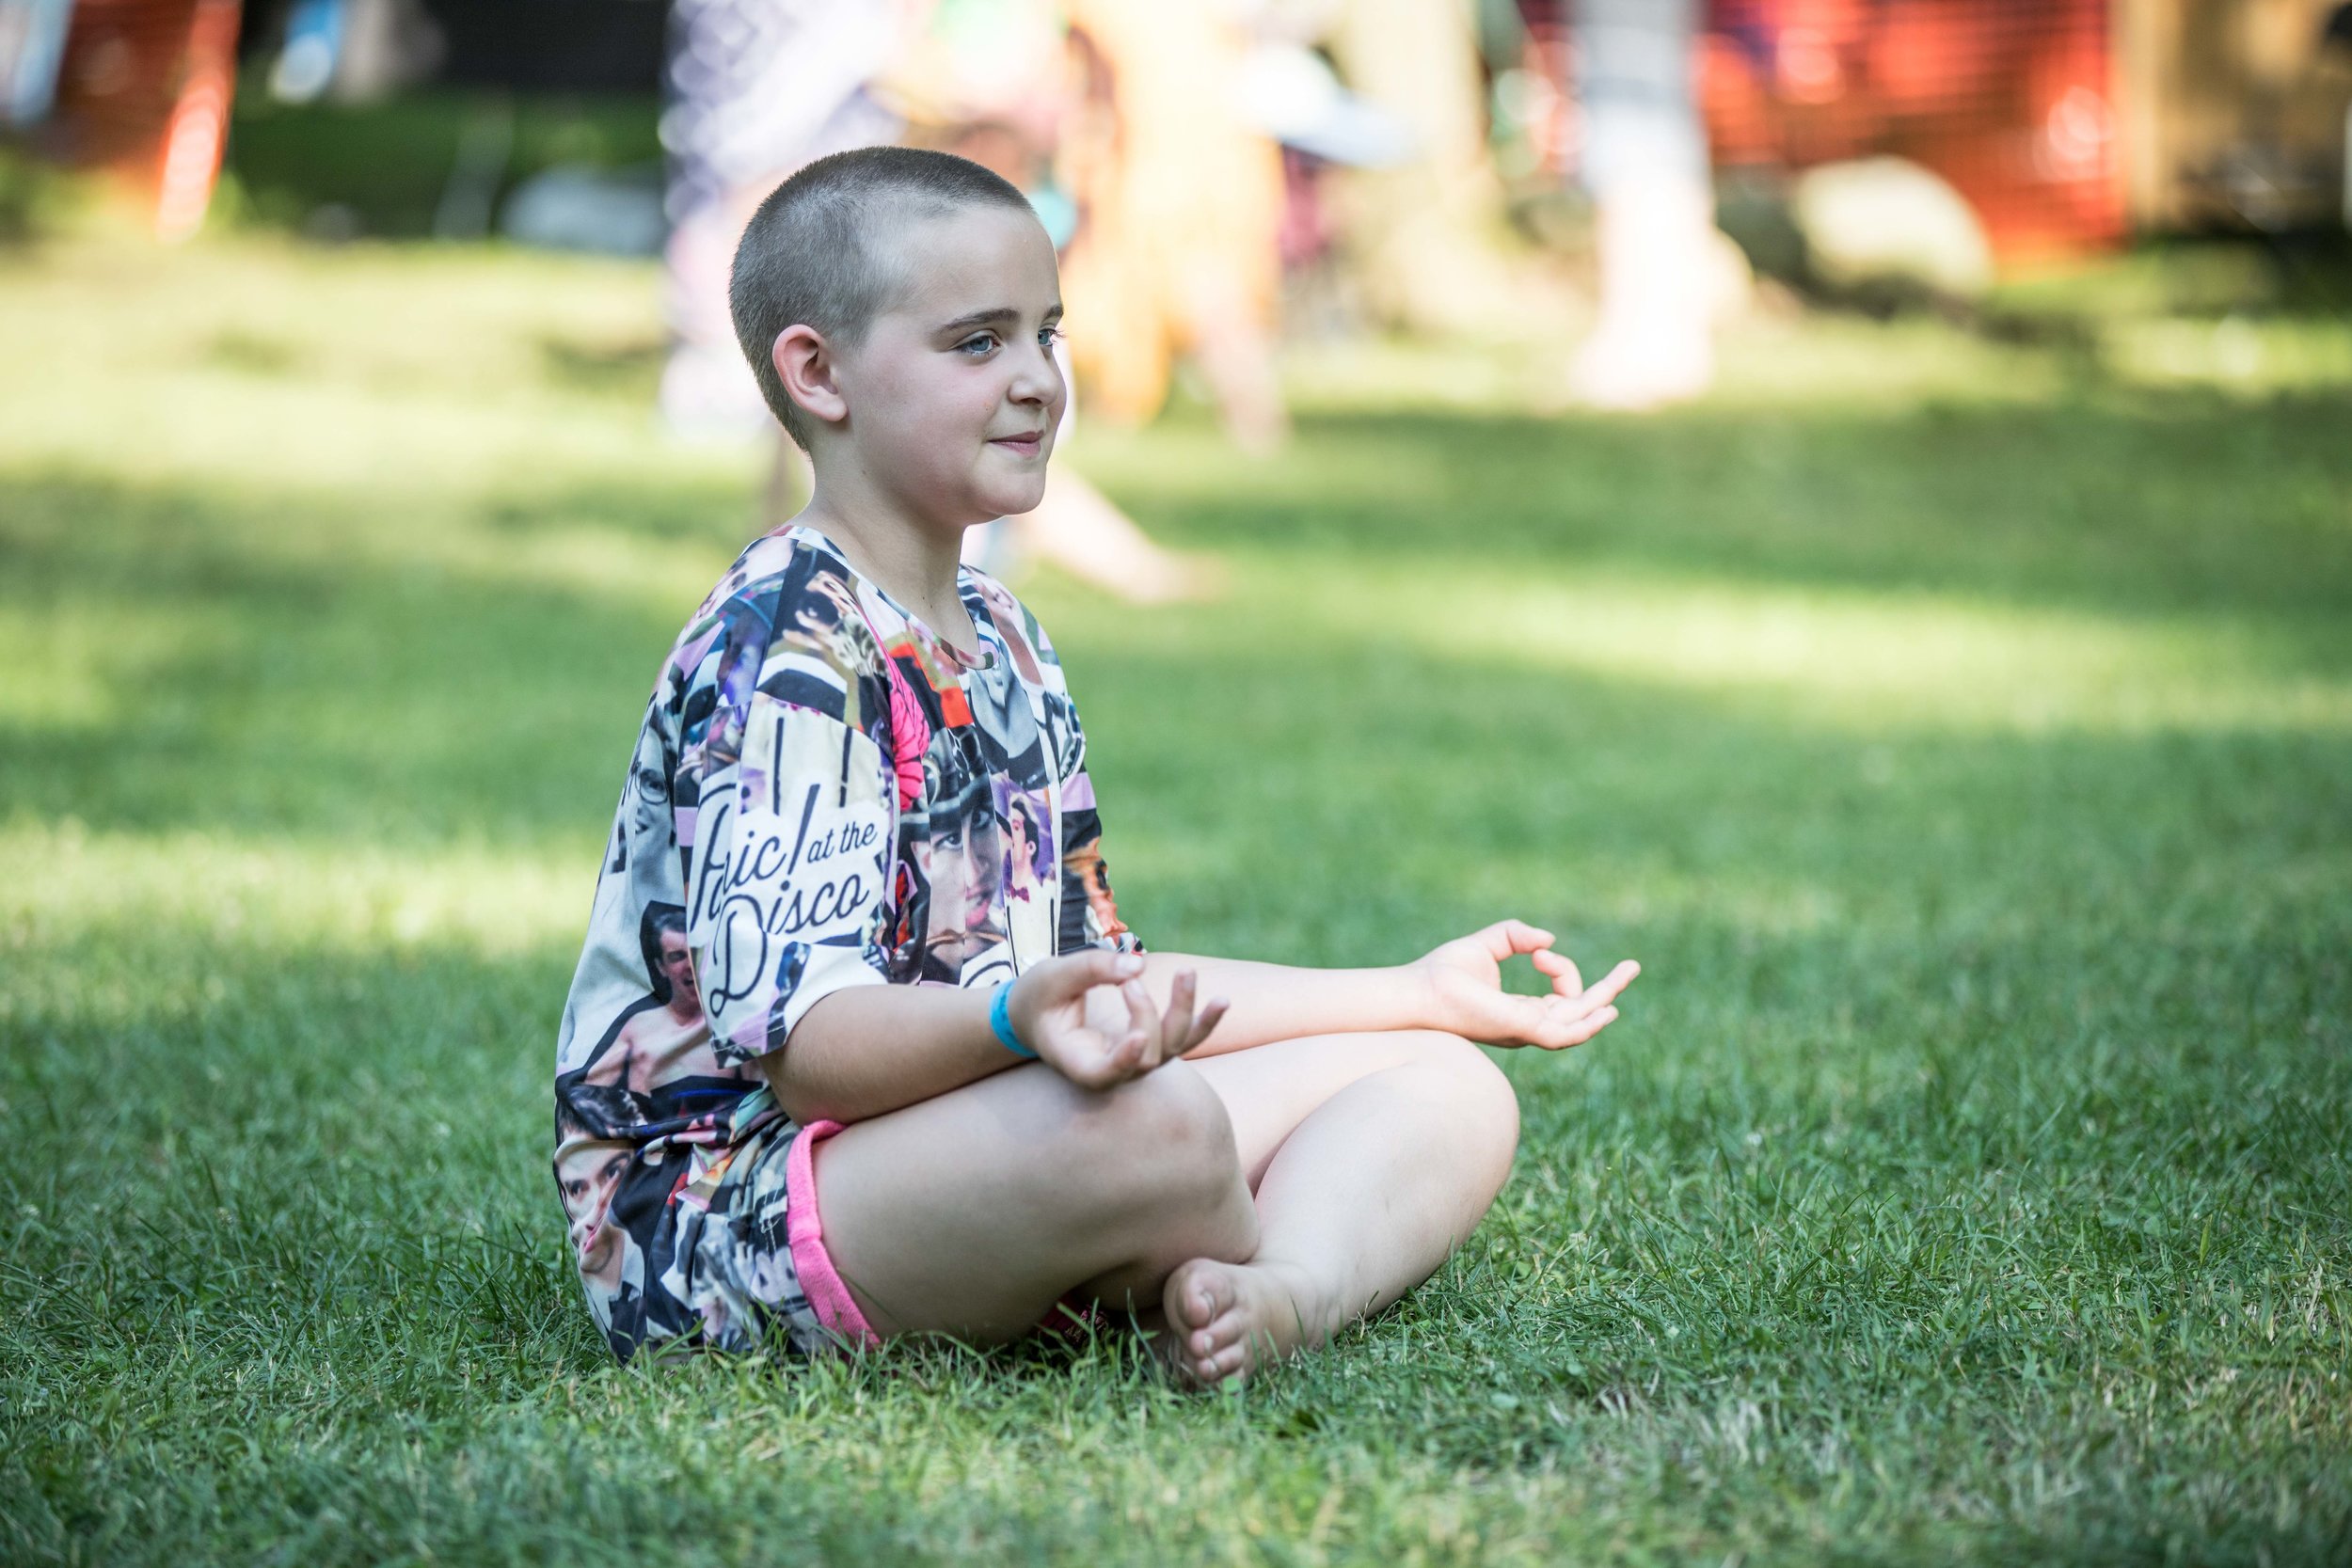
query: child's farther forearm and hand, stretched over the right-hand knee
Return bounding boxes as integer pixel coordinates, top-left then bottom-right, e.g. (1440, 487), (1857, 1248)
(1143, 919), (1642, 1055)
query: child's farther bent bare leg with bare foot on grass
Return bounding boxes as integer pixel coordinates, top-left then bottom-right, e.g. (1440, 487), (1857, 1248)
(1162, 1032), (1519, 1383)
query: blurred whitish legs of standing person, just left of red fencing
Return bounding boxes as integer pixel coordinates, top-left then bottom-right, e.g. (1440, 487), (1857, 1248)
(1569, 0), (1720, 409)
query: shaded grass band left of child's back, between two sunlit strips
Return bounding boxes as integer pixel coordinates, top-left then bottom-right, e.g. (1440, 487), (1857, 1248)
(0, 474), (691, 844)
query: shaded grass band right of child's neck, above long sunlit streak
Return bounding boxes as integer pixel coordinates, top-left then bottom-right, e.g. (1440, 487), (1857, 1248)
(1113, 392), (2352, 616)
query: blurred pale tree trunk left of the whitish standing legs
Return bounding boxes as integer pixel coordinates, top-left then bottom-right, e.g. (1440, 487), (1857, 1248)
(1331, 0), (1519, 331)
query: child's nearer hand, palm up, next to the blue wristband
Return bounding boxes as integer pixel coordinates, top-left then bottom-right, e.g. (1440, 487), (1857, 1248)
(1005, 947), (1226, 1088)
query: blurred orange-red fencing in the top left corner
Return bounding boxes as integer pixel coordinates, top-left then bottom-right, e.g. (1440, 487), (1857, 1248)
(42, 0), (240, 240)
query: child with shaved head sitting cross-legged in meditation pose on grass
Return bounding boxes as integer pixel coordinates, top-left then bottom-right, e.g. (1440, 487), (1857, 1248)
(555, 148), (1635, 1383)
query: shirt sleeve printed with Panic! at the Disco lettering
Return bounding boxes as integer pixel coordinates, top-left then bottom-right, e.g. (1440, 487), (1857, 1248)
(680, 587), (894, 1063)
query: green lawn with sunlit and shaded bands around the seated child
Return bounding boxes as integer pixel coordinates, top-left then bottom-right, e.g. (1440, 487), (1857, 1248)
(0, 223), (2352, 1566)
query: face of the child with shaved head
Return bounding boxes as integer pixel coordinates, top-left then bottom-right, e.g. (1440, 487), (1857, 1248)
(835, 207), (1068, 529)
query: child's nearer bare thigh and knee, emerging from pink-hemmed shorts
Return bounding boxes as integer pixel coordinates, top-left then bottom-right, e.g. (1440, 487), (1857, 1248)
(812, 1063), (1259, 1345)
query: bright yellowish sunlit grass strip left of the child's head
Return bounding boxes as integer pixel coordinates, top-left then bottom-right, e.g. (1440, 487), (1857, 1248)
(0, 242), (696, 496)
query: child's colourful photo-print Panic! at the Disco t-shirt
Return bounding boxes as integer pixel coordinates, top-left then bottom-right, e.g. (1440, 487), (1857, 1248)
(555, 529), (1136, 1356)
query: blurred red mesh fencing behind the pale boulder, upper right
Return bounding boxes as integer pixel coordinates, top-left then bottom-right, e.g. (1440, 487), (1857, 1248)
(1698, 0), (2126, 263)
